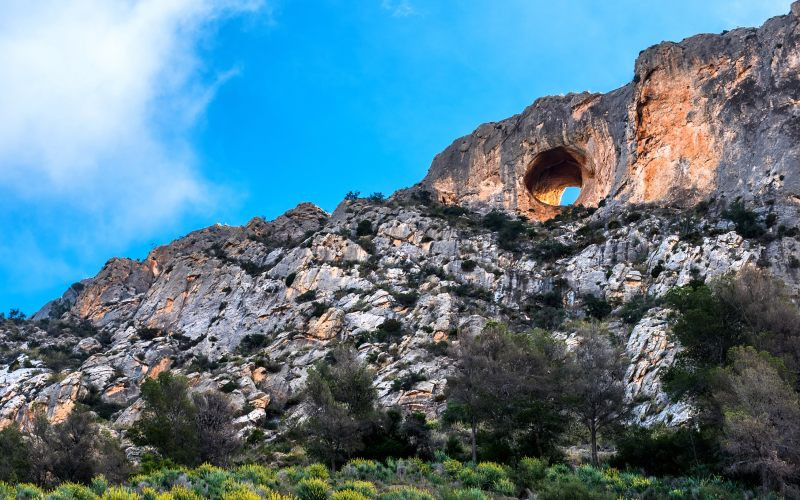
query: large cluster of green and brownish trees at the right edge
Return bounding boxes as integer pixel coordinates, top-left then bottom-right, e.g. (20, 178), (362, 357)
(664, 268), (800, 496)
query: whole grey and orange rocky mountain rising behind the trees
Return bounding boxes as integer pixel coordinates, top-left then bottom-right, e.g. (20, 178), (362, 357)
(0, 2), (800, 446)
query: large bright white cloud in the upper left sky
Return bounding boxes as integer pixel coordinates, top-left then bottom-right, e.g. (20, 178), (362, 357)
(0, 0), (263, 239)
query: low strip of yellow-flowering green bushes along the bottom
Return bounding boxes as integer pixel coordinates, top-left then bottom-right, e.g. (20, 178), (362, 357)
(0, 456), (769, 500)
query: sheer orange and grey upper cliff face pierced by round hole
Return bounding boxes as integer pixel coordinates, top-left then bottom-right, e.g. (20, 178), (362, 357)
(422, 3), (800, 220)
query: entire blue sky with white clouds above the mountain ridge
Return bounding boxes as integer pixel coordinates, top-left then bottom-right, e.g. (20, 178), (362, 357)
(0, 0), (790, 313)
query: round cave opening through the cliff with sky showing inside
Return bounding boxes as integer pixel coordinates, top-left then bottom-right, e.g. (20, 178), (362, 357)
(524, 147), (586, 206)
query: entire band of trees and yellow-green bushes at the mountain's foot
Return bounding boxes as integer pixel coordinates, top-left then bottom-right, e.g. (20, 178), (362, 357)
(0, 268), (800, 494)
